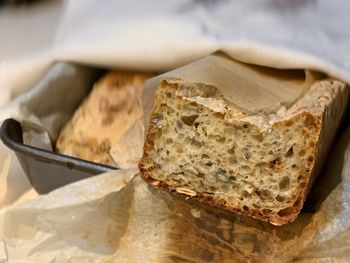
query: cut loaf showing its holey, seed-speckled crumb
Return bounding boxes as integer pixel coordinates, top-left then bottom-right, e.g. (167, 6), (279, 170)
(139, 74), (349, 225)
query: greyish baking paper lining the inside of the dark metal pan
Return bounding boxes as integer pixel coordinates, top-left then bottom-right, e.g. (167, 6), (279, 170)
(7, 63), (102, 150)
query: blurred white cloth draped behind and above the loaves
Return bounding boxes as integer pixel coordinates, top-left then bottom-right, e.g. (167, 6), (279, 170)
(0, 0), (350, 102)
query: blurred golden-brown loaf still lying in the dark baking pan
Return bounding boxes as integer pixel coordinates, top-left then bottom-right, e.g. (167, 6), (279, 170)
(56, 72), (149, 164)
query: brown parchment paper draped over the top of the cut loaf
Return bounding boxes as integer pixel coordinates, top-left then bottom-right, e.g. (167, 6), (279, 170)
(142, 52), (322, 128)
